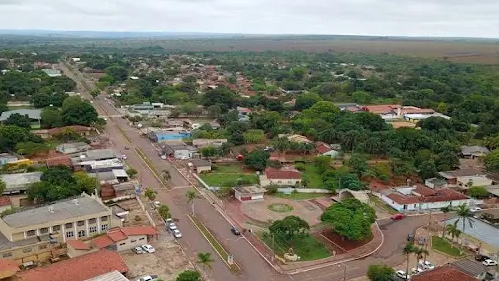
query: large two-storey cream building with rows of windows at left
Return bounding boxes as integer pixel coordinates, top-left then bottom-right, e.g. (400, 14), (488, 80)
(0, 194), (122, 262)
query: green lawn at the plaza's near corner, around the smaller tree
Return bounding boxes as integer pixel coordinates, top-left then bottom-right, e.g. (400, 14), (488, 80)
(260, 232), (331, 261)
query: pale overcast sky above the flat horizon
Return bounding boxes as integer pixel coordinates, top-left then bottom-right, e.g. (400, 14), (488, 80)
(0, 0), (499, 38)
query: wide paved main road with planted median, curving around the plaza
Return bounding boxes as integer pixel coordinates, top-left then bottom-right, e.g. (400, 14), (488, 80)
(61, 61), (440, 281)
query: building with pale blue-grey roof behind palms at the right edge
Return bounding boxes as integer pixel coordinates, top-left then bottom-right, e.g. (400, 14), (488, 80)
(444, 218), (499, 257)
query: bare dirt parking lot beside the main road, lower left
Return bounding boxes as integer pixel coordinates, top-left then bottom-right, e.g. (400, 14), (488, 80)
(122, 232), (193, 281)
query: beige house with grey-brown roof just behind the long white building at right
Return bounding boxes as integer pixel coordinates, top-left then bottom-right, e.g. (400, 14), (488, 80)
(438, 169), (492, 189)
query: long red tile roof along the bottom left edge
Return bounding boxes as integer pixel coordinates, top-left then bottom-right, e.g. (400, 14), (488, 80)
(17, 250), (128, 281)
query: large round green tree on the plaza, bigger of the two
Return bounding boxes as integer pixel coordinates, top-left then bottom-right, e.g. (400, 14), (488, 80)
(321, 198), (376, 240)
